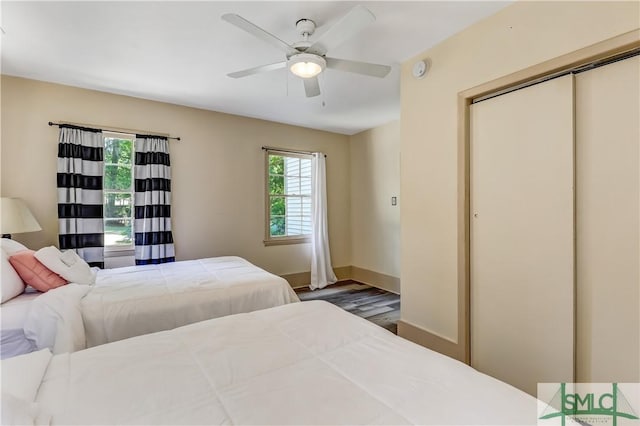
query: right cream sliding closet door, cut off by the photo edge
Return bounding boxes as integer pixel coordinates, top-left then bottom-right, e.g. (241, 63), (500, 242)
(576, 56), (640, 383)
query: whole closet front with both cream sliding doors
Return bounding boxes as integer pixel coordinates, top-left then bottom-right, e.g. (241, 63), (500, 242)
(469, 56), (640, 395)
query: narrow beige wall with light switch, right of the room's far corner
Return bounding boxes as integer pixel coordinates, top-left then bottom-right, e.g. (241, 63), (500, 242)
(350, 121), (402, 291)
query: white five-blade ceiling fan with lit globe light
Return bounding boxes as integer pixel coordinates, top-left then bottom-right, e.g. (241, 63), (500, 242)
(222, 6), (391, 97)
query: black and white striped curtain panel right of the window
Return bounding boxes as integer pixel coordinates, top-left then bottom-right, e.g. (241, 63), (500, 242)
(134, 135), (175, 265)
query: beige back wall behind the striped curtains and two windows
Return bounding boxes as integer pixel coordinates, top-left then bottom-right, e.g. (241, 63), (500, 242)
(1, 76), (351, 274)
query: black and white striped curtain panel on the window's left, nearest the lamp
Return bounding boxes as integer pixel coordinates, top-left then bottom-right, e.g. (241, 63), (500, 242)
(57, 125), (104, 268)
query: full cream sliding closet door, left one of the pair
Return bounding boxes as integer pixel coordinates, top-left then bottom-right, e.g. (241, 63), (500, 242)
(470, 75), (574, 395)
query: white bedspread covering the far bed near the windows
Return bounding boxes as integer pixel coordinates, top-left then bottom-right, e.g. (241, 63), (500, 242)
(25, 256), (299, 353)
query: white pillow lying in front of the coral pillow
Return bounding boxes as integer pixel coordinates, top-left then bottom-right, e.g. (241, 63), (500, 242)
(34, 246), (96, 285)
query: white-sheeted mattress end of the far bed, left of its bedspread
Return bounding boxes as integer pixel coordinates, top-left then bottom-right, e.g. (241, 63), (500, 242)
(0, 291), (40, 359)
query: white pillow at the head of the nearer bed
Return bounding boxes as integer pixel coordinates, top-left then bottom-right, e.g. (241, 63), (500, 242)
(0, 349), (51, 402)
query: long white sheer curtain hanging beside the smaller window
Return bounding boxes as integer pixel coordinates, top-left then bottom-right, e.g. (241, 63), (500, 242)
(309, 152), (338, 290)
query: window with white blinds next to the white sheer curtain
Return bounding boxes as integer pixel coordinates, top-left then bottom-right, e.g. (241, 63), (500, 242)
(265, 150), (312, 245)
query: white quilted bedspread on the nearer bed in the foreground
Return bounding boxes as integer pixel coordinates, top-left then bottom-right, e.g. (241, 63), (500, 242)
(36, 301), (537, 425)
